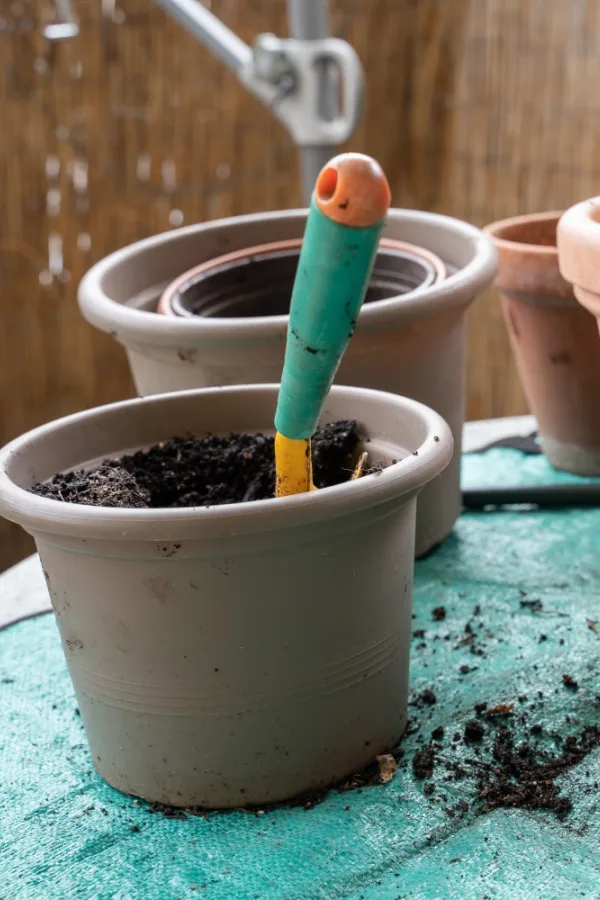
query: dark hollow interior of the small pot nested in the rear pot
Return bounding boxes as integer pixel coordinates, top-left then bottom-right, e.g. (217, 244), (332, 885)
(172, 248), (437, 318)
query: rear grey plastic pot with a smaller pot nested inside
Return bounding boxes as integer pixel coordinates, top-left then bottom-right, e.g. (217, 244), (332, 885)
(79, 209), (497, 556)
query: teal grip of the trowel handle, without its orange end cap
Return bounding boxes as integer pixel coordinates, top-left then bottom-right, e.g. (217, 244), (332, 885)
(275, 200), (383, 440)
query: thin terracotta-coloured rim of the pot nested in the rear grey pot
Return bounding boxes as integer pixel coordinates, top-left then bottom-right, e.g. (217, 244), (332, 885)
(156, 237), (447, 325)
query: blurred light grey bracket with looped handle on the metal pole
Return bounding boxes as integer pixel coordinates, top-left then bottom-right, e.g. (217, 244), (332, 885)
(243, 34), (363, 146)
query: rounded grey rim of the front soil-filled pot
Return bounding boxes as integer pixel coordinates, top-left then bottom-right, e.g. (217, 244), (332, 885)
(0, 384), (453, 541)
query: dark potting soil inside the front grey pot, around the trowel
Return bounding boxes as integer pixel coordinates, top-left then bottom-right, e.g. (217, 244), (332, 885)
(31, 421), (360, 509)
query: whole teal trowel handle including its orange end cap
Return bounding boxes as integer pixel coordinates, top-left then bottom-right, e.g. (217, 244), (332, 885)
(275, 153), (390, 440)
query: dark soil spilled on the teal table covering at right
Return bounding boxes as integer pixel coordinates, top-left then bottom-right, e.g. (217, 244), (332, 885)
(408, 591), (600, 818)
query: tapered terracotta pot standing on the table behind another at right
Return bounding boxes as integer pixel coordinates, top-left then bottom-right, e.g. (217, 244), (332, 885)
(487, 212), (600, 475)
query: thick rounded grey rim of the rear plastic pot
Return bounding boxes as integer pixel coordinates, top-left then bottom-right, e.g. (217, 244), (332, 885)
(78, 209), (497, 348)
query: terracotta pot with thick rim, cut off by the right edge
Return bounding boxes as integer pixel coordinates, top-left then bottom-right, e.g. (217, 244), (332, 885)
(558, 197), (600, 338)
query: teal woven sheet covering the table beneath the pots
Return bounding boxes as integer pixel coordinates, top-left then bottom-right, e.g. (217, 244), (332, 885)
(0, 450), (600, 900)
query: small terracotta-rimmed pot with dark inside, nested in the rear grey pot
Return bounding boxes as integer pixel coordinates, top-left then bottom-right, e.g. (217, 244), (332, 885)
(156, 238), (446, 318)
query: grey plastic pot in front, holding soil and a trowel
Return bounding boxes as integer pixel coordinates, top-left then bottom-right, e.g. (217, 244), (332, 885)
(0, 385), (452, 808)
